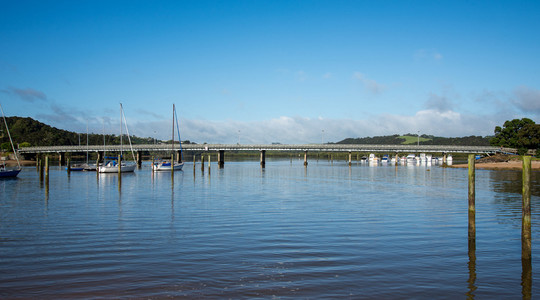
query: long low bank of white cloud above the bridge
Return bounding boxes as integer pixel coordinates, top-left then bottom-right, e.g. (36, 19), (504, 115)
(122, 109), (500, 144)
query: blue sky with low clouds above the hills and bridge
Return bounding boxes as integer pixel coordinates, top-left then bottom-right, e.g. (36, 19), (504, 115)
(0, 0), (540, 144)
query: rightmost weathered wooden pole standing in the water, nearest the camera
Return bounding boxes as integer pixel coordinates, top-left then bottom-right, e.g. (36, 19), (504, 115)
(521, 156), (531, 260)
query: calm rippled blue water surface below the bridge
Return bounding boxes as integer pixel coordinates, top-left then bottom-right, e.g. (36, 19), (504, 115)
(0, 161), (540, 299)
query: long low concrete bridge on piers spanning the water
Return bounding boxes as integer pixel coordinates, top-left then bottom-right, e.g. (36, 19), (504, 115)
(18, 144), (506, 167)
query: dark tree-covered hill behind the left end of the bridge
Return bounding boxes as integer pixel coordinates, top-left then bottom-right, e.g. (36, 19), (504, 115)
(0, 117), (153, 149)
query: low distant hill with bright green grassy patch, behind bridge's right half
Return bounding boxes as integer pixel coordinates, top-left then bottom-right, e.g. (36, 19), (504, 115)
(336, 134), (491, 146)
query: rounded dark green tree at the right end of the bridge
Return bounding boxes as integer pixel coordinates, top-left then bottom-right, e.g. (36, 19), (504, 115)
(490, 118), (540, 154)
